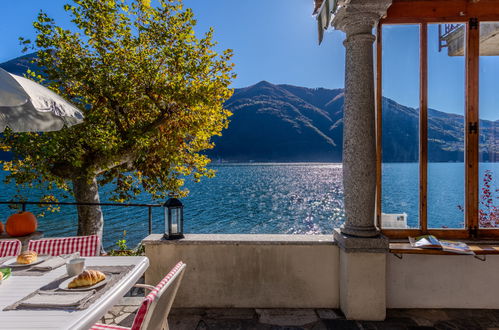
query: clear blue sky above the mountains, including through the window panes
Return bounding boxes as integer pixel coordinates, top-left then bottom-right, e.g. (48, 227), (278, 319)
(0, 0), (499, 120)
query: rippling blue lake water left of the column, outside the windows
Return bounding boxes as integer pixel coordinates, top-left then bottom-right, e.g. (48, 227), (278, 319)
(0, 163), (344, 248)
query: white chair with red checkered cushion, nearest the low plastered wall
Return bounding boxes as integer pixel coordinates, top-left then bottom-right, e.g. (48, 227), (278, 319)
(90, 261), (186, 330)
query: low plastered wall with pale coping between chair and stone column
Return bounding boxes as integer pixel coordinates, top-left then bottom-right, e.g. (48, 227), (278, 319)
(143, 235), (339, 308)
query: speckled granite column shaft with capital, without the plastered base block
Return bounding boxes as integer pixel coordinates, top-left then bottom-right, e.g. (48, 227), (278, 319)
(333, 0), (391, 237)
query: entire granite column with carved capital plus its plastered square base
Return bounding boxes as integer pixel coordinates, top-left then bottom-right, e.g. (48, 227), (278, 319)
(333, 0), (391, 320)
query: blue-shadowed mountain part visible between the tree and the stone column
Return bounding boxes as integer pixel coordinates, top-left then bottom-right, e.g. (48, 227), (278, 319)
(210, 81), (342, 162)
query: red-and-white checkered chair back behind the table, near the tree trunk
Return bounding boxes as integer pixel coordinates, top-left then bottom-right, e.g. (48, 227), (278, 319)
(28, 235), (100, 257)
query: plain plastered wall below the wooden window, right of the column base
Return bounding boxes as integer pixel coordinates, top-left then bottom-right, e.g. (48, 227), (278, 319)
(387, 254), (499, 309)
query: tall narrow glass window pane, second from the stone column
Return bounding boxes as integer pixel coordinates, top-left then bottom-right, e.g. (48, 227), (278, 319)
(427, 24), (466, 229)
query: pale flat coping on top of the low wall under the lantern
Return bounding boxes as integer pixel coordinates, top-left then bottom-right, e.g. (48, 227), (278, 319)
(142, 234), (336, 245)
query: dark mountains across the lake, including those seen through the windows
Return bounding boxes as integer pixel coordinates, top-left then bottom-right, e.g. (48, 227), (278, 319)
(0, 54), (499, 162)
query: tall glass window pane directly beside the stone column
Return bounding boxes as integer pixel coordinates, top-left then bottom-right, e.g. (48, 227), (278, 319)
(381, 25), (419, 228)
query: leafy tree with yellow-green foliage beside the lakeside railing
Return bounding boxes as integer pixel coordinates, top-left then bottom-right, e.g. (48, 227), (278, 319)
(1, 0), (235, 240)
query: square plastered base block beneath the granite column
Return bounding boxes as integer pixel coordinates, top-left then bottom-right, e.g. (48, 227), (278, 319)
(334, 229), (389, 321)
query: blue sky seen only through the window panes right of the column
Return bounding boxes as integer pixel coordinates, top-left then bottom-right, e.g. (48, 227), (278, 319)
(382, 24), (499, 120)
